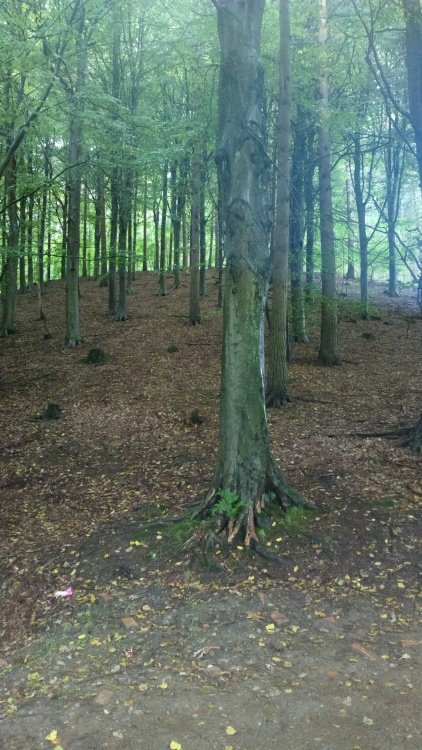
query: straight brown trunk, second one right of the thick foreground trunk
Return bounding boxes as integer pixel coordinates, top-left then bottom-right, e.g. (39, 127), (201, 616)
(318, 0), (340, 366)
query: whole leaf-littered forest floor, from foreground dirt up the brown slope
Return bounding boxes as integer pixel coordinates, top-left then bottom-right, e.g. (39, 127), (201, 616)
(0, 274), (422, 750)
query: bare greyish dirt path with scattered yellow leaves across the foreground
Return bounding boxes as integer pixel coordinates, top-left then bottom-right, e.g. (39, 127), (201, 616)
(0, 576), (422, 750)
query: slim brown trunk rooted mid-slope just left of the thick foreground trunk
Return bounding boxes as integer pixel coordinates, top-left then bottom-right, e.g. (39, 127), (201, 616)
(189, 148), (201, 326)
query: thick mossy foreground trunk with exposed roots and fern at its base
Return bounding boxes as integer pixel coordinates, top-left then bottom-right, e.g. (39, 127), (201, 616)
(204, 0), (310, 545)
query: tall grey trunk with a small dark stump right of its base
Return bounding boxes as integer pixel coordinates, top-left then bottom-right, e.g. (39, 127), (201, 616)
(64, 0), (87, 348)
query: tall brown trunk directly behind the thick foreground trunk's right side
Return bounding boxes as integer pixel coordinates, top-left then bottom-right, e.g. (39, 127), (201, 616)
(266, 0), (291, 408)
